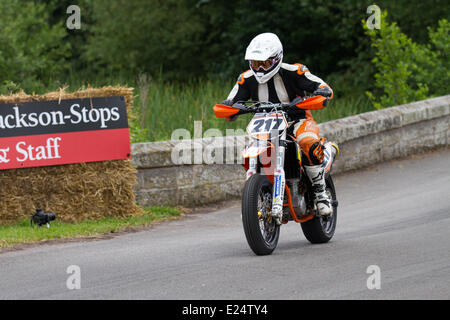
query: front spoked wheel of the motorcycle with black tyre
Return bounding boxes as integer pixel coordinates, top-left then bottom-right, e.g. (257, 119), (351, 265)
(242, 174), (280, 255)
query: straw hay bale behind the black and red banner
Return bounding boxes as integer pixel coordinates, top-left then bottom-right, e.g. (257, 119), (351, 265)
(0, 87), (142, 224)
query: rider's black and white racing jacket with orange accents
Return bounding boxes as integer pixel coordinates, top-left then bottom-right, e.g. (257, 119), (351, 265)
(227, 63), (331, 120)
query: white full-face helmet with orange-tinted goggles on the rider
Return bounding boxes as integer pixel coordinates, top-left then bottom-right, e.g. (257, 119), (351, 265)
(245, 33), (283, 83)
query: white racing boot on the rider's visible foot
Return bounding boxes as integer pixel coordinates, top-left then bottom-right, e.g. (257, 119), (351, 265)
(304, 165), (333, 216)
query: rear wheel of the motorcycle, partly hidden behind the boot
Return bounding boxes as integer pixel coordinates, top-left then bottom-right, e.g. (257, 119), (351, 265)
(301, 176), (337, 243)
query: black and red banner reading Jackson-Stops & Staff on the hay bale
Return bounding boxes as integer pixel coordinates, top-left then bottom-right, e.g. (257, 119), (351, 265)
(0, 97), (130, 170)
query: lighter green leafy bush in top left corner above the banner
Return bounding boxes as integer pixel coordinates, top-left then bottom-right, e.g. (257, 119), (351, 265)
(0, 0), (70, 93)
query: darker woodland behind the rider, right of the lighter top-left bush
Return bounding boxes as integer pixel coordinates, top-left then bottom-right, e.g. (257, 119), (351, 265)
(81, 0), (449, 95)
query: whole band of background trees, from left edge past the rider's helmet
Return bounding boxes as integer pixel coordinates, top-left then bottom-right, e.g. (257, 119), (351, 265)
(0, 0), (450, 95)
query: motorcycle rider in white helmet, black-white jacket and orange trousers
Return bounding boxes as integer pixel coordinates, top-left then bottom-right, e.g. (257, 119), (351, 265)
(222, 33), (333, 215)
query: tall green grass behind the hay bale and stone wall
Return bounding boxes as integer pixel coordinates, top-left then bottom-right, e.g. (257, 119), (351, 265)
(22, 74), (374, 142)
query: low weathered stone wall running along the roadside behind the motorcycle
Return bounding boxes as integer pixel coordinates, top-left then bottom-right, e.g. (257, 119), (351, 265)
(132, 95), (450, 206)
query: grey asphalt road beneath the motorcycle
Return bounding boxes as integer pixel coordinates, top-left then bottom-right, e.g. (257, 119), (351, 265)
(0, 149), (450, 299)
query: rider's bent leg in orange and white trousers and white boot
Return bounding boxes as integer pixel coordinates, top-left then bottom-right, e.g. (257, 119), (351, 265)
(294, 119), (333, 215)
